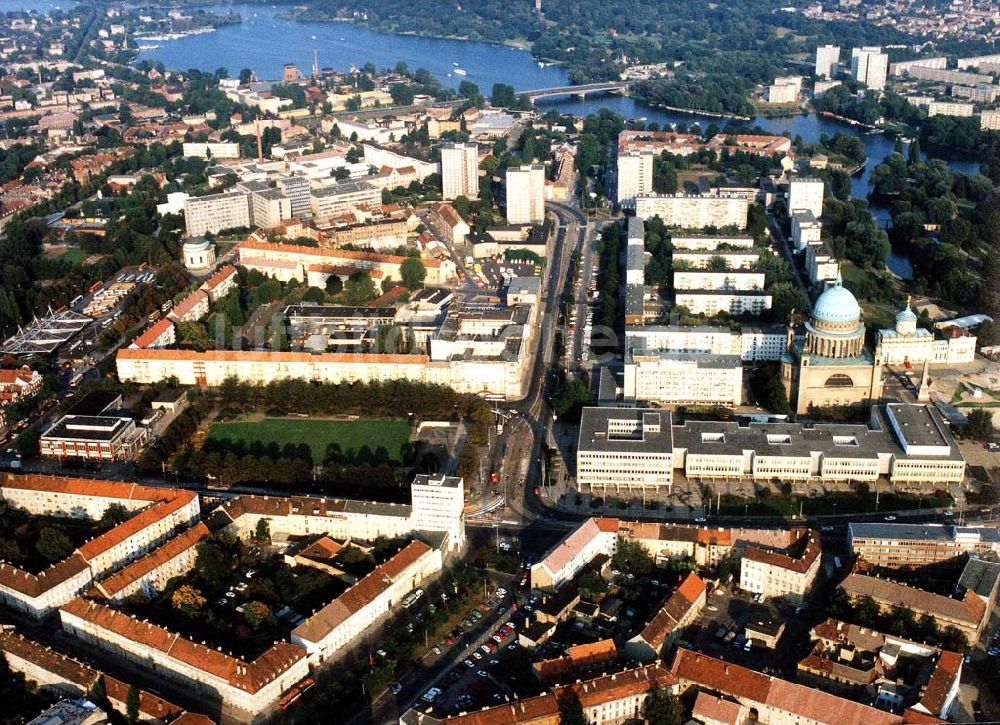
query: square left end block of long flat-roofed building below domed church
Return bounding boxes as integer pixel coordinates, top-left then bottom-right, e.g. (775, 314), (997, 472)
(576, 408), (673, 493)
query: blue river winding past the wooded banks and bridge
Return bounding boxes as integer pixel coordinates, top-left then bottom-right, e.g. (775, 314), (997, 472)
(11, 0), (979, 277)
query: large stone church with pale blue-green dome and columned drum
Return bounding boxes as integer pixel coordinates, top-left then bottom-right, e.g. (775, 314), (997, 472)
(781, 275), (884, 414)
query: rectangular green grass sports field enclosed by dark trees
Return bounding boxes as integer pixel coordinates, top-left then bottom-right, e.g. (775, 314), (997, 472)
(206, 418), (410, 465)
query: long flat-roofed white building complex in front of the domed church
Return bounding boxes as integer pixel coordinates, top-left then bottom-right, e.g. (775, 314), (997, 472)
(577, 403), (965, 490)
